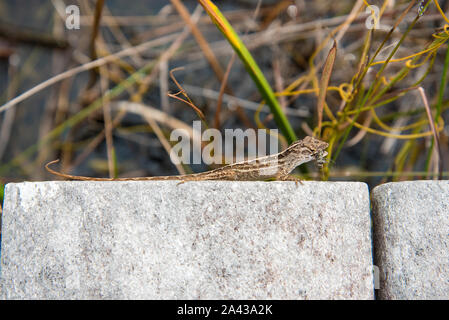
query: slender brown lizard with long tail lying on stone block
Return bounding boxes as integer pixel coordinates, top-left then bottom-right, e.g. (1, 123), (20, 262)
(45, 136), (329, 182)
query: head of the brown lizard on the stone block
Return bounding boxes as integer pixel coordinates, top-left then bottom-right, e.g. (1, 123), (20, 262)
(287, 136), (329, 167)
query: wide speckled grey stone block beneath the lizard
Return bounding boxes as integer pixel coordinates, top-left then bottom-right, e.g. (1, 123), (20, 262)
(1, 181), (374, 299)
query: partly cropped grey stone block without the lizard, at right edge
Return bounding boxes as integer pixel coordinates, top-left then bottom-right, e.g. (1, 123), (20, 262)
(372, 181), (449, 299)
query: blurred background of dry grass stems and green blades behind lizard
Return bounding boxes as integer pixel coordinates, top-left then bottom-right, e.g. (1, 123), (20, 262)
(0, 0), (449, 206)
